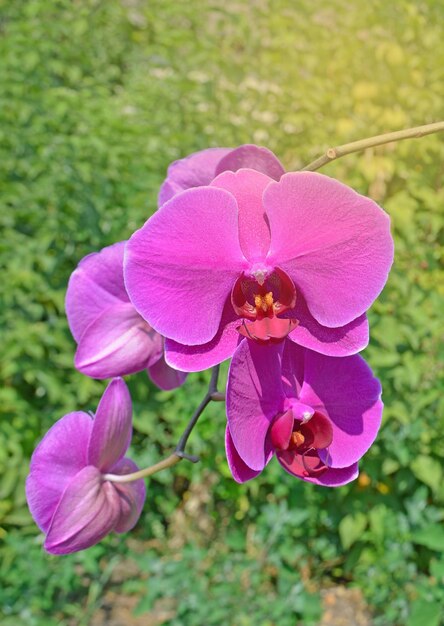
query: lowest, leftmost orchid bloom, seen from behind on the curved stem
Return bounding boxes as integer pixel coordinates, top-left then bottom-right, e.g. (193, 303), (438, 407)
(26, 378), (146, 554)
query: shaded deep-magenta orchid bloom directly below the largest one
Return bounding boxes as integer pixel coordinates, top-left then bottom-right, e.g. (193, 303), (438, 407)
(226, 340), (383, 487)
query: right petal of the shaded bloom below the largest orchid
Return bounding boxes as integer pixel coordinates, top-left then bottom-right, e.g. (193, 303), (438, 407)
(301, 350), (383, 468)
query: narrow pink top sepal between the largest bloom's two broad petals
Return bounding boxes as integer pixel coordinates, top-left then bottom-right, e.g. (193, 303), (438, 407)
(211, 169), (272, 262)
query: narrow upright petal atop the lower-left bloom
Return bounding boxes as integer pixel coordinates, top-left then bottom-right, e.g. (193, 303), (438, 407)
(88, 378), (132, 471)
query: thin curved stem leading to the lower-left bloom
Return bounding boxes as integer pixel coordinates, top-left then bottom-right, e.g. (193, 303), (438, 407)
(103, 365), (225, 483)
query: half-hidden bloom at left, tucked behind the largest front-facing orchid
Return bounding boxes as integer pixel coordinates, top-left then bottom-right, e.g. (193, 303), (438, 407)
(66, 241), (186, 390)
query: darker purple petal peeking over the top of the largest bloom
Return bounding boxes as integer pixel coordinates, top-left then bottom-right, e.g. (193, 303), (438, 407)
(216, 144), (285, 180)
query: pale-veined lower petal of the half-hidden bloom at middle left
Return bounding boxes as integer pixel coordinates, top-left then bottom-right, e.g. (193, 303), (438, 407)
(74, 302), (163, 378)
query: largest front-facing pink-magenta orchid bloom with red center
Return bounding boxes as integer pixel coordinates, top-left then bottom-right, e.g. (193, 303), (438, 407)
(124, 154), (393, 371)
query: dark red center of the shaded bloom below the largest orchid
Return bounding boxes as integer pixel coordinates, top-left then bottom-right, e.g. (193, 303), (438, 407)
(270, 409), (333, 478)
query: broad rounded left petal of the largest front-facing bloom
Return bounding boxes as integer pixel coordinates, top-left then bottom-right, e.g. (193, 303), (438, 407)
(125, 187), (247, 345)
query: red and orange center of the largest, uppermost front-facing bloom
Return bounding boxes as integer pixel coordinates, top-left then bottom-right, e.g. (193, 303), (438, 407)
(231, 267), (298, 342)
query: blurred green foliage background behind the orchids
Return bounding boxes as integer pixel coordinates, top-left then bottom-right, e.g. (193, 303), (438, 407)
(0, 0), (444, 626)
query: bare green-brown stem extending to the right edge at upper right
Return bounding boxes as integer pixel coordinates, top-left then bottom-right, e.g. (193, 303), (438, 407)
(302, 122), (444, 172)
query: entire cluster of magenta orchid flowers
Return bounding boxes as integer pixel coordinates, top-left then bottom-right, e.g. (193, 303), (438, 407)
(27, 145), (393, 554)
